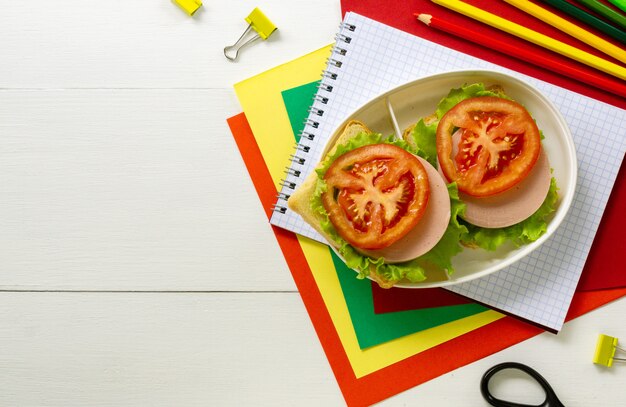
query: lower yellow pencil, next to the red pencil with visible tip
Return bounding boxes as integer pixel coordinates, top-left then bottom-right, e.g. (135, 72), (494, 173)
(431, 0), (626, 80)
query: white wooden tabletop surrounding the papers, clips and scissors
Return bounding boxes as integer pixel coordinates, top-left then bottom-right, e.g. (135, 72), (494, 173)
(0, 0), (626, 406)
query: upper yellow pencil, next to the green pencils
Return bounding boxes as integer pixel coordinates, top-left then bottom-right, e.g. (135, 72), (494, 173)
(504, 0), (626, 63)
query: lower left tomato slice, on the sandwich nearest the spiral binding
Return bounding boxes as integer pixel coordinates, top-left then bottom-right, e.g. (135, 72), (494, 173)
(322, 144), (430, 250)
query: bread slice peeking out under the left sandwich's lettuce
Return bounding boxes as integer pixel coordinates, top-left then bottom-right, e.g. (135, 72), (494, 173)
(287, 120), (394, 288)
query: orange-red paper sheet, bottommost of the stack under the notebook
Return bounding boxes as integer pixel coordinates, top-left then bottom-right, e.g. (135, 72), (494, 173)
(228, 113), (626, 406)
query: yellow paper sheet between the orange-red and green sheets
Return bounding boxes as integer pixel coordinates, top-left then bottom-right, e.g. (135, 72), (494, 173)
(235, 46), (504, 378)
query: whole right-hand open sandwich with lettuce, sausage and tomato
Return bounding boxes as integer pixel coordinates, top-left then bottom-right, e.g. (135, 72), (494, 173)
(403, 83), (558, 250)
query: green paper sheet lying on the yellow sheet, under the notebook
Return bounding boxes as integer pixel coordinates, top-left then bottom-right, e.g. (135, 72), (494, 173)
(281, 82), (488, 349)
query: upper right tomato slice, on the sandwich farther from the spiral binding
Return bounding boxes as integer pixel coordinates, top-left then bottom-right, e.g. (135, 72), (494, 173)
(437, 96), (541, 197)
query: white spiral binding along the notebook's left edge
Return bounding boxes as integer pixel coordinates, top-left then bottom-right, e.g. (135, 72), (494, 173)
(272, 23), (356, 214)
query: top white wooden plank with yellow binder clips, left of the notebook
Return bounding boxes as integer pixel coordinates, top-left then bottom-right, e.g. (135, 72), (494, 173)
(0, 0), (341, 89)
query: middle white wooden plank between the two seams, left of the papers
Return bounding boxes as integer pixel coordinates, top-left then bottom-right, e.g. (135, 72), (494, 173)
(0, 90), (295, 291)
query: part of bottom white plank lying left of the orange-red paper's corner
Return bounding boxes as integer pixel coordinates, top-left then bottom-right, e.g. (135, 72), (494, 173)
(0, 293), (341, 407)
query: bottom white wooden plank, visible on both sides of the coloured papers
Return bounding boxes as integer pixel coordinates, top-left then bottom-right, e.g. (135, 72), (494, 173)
(0, 293), (626, 407)
